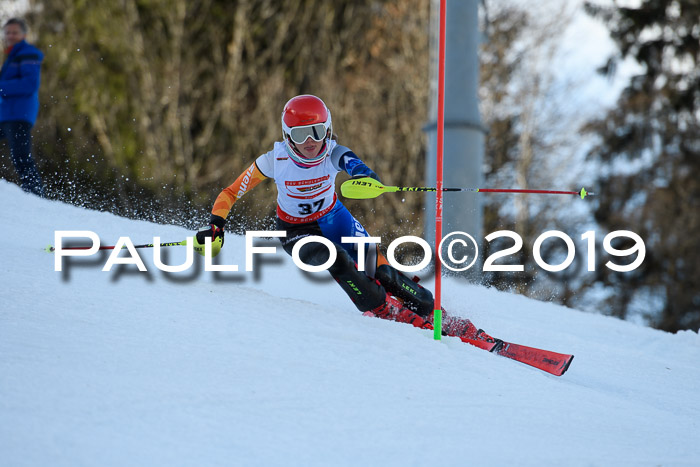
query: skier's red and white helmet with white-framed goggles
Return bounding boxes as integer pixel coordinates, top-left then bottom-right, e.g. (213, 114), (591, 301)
(282, 94), (333, 167)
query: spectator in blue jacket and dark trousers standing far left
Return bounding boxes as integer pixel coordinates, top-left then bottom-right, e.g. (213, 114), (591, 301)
(0, 18), (44, 196)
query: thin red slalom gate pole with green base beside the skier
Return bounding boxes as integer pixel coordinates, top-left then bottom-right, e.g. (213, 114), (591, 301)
(433, 0), (447, 341)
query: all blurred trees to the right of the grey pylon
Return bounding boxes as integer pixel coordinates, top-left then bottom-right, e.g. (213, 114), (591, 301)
(470, 0), (700, 331)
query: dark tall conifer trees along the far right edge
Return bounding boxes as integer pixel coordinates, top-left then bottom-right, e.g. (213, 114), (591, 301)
(587, 0), (700, 331)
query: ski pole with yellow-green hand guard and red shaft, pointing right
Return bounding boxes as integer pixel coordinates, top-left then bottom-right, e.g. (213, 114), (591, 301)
(340, 177), (595, 199)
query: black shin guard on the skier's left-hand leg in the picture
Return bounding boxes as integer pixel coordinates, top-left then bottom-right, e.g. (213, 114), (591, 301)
(299, 239), (386, 311)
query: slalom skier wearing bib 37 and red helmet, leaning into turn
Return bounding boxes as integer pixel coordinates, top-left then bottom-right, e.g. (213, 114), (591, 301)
(195, 95), (476, 335)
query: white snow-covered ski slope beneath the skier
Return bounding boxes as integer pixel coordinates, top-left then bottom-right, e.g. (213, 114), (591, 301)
(0, 181), (700, 466)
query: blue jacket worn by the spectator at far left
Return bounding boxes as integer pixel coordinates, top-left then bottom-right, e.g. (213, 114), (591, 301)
(0, 41), (44, 125)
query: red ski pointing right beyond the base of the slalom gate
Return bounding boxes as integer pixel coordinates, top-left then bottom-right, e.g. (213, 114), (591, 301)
(460, 336), (574, 376)
